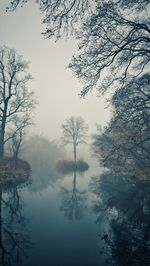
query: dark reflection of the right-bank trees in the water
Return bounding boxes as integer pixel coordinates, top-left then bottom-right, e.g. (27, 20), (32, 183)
(90, 173), (150, 266)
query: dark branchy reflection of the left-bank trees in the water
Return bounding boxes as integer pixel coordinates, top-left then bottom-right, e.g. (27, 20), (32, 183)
(0, 180), (31, 266)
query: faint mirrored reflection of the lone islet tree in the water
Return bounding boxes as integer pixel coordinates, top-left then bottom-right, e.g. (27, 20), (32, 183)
(60, 171), (87, 220)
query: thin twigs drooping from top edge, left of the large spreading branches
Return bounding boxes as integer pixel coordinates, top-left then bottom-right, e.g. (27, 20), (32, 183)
(6, 0), (92, 40)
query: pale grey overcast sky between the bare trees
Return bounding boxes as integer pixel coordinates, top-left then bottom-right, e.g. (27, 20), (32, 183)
(0, 0), (109, 139)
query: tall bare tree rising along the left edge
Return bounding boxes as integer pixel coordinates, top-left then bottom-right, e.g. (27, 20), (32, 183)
(0, 47), (36, 158)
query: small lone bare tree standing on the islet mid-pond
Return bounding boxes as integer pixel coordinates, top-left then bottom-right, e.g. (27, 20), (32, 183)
(62, 116), (88, 163)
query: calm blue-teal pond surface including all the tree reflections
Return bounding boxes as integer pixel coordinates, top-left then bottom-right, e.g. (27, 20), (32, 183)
(0, 165), (150, 266)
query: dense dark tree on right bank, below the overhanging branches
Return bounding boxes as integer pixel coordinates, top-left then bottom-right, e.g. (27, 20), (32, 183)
(93, 74), (150, 175)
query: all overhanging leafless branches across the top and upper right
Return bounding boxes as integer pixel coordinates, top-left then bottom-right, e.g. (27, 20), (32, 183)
(6, 0), (150, 96)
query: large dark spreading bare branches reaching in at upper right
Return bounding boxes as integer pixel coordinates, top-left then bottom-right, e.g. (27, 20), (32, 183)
(70, 1), (150, 96)
